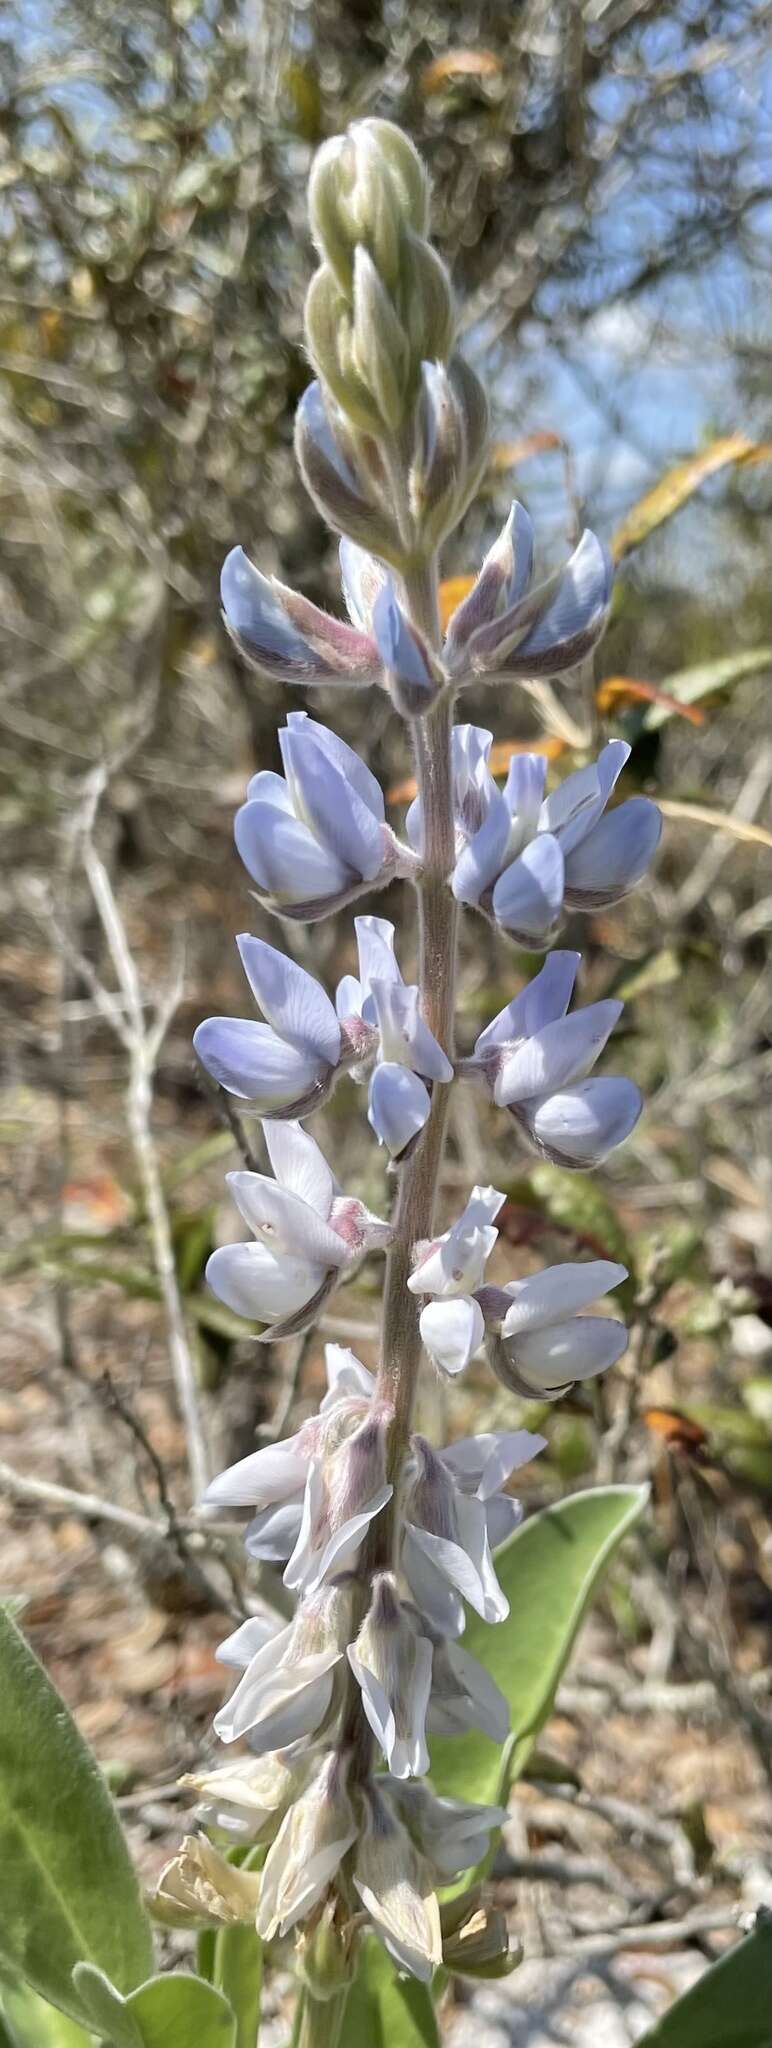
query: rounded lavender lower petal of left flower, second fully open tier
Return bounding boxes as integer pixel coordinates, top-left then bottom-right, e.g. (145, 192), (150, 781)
(192, 1018), (321, 1110)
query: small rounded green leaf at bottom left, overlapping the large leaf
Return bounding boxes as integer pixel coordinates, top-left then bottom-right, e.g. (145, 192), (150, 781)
(74, 1962), (236, 2048)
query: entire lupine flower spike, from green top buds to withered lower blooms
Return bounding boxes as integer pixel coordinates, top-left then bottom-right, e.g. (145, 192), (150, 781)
(176, 121), (659, 1997)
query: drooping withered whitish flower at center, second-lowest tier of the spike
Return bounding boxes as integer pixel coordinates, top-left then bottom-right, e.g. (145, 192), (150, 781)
(348, 1571), (432, 1778)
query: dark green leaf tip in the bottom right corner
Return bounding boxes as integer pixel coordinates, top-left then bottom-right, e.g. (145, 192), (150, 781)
(639, 1913), (772, 2048)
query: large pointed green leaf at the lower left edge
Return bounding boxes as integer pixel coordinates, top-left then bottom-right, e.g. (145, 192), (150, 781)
(0, 1614), (154, 2019)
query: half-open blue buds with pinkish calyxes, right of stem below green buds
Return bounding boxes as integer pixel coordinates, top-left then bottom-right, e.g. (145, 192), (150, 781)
(444, 504), (614, 686)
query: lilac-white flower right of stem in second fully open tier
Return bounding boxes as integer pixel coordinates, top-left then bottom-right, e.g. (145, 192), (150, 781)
(466, 952), (643, 1167)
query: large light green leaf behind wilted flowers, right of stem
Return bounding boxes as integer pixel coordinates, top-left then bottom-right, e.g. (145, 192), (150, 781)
(432, 1487), (649, 1802)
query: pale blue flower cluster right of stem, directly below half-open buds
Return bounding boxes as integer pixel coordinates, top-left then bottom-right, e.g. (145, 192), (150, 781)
(423, 725), (661, 946)
